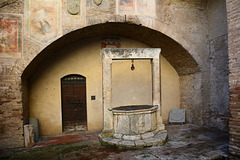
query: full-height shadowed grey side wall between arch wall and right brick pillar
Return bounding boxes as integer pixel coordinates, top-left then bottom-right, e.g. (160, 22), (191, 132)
(206, 0), (229, 131)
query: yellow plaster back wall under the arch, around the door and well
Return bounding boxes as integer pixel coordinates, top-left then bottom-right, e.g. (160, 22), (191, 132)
(29, 38), (180, 135)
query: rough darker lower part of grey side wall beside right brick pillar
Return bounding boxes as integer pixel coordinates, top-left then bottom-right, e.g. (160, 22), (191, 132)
(206, 34), (229, 131)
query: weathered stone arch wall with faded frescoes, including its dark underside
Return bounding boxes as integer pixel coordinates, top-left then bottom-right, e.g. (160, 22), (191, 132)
(0, 0), (230, 147)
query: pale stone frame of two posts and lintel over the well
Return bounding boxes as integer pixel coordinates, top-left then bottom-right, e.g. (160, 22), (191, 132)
(101, 48), (165, 137)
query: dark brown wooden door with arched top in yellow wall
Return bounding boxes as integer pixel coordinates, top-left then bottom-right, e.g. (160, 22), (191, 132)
(61, 75), (87, 132)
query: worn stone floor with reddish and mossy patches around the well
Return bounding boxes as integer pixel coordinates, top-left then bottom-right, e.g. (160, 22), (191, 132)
(0, 124), (228, 160)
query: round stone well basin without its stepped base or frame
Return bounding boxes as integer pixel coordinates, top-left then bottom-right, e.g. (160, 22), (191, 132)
(112, 105), (157, 140)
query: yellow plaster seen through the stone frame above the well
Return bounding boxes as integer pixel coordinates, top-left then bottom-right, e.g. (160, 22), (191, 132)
(112, 59), (153, 107)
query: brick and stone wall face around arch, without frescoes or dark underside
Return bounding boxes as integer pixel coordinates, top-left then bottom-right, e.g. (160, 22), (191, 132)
(0, 0), (227, 147)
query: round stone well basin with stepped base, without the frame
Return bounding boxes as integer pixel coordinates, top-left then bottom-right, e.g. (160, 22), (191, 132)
(100, 105), (167, 149)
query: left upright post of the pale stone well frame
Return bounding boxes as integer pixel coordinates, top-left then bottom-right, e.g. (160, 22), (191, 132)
(102, 54), (113, 137)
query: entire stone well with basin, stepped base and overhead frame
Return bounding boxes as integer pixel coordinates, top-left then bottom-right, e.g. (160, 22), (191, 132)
(99, 48), (167, 149)
